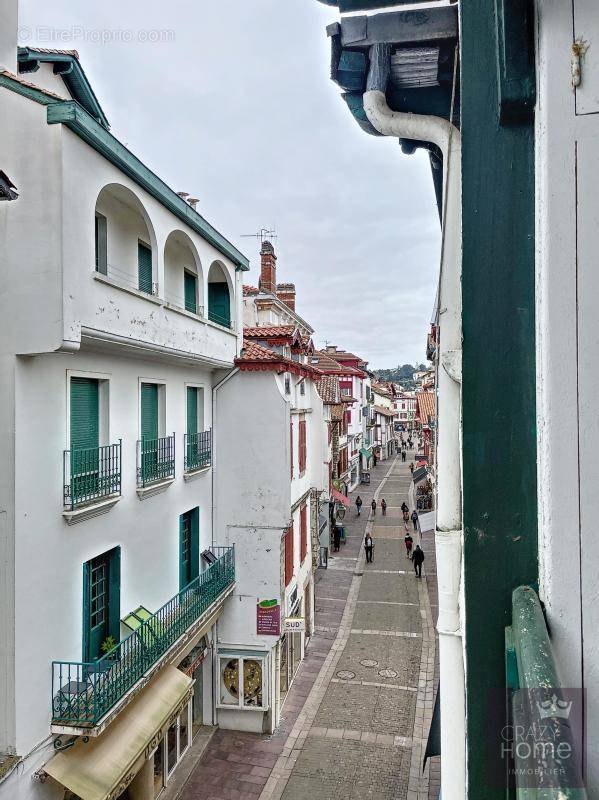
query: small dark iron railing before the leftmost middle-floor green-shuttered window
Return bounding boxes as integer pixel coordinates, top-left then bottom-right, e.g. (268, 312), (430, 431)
(63, 439), (122, 511)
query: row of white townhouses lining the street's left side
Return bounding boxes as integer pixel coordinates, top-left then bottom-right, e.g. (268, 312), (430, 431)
(0, 6), (394, 800)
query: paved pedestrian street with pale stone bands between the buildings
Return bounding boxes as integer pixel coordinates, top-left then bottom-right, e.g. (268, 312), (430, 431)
(176, 453), (438, 800)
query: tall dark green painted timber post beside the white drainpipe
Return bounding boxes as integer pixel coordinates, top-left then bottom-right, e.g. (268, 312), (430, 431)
(460, 0), (538, 800)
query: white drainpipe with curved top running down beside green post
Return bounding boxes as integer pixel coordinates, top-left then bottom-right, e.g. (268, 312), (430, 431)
(364, 45), (466, 800)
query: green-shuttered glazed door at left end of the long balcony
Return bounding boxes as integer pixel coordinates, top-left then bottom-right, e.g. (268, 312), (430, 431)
(83, 547), (121, 662)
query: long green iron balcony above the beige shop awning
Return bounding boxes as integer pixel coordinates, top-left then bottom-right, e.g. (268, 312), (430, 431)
(52, 547), (235, 729)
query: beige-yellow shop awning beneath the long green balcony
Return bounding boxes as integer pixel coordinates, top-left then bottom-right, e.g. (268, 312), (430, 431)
(44, 666), (193, 800)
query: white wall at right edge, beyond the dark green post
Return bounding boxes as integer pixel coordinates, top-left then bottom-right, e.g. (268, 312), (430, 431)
(536, 0), (599, 796)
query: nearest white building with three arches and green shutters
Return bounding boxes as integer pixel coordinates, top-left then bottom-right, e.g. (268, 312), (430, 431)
(0, 23), (248, 800)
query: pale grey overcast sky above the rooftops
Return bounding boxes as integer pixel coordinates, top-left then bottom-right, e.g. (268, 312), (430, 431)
(20, 0), (440, 368)
